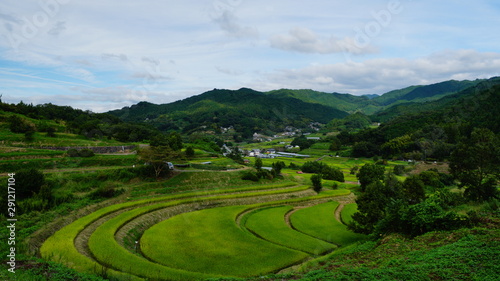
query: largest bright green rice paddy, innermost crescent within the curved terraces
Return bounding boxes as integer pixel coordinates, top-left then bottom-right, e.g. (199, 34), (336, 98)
(141, 206), (308, 277)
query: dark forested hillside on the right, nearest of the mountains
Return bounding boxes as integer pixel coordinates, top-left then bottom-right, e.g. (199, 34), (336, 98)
(339, 77), (500, 160)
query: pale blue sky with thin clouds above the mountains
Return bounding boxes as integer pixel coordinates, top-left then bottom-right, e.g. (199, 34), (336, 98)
(0, 0), (500, 112)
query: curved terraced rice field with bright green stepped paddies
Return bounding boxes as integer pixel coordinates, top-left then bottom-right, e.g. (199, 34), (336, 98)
(40, 178), (364, 280)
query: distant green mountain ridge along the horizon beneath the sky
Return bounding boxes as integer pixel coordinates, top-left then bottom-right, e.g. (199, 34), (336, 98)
(109, 76), (494, 134)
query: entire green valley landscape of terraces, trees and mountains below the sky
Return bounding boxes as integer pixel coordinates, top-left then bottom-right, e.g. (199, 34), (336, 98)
(0, 78), (500, 281)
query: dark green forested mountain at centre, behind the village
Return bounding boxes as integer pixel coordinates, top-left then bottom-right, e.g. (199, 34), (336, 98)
(109, 88), (348, 138)
